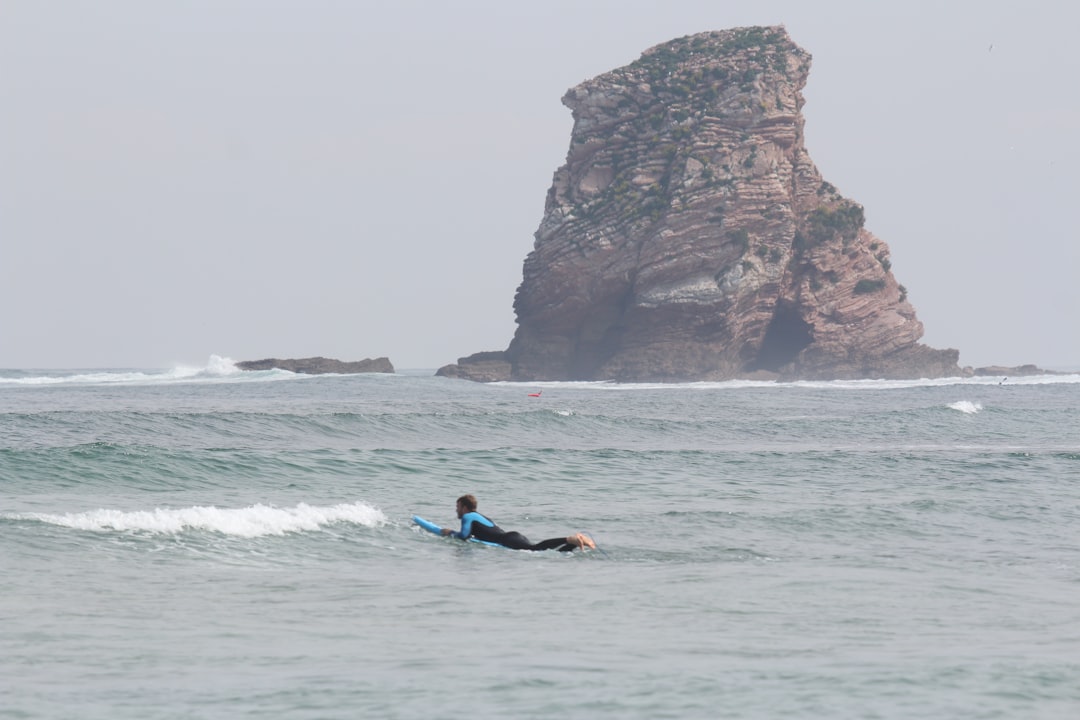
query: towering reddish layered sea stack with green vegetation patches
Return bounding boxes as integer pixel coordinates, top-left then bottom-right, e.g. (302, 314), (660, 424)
(440, 27), (960, 381)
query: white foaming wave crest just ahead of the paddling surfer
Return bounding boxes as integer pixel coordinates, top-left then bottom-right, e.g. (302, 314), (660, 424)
(6, 503), (387, 538)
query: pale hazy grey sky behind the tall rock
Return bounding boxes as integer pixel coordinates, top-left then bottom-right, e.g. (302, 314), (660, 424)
(0, 0), (1080, 369)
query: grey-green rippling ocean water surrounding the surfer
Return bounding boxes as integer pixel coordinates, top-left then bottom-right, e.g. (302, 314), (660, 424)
(0, 358), (1080, 720)
